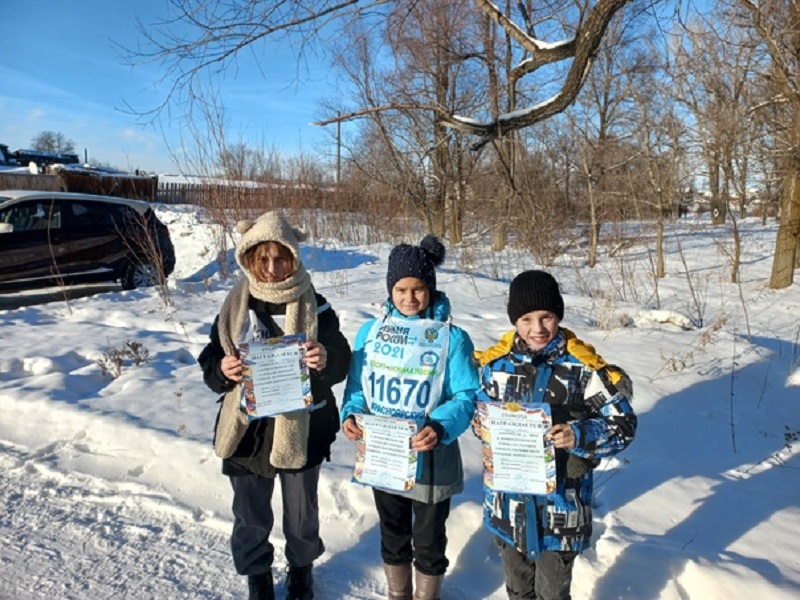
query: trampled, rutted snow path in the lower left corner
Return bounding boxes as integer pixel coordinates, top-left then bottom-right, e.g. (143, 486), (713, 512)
(0, 442), (238, 600)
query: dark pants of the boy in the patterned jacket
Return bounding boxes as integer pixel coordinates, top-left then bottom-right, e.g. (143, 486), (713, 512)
(494, 538), (578, 600)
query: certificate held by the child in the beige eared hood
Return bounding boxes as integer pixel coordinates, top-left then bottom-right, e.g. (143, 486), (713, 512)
(239, 333), (313, 419)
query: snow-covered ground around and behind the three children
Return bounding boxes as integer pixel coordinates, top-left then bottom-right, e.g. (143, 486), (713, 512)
(0, 207), (800, 600)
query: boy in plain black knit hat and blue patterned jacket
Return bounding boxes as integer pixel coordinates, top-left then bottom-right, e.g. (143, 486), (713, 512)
(474, 271), (636, 600)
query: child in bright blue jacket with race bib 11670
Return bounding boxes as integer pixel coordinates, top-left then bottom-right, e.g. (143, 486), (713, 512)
(341, 235), (479, 600)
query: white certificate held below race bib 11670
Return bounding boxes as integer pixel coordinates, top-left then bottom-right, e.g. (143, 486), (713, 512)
(353, 415), (417, 492)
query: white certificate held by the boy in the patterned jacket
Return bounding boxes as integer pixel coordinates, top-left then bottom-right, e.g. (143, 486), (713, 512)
(484, 402), (556, 495)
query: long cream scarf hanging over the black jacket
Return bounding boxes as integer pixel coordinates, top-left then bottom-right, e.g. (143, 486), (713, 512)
(214, 263), (317, 469)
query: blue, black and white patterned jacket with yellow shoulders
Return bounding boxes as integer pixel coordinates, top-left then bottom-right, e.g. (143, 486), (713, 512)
(476, 328), (637, 558)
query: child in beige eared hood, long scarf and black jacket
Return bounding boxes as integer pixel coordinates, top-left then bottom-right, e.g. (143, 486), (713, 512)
(198, 211), (350, 600)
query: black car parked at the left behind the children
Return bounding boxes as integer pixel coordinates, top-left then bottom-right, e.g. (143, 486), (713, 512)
(0, 190), (175, 291)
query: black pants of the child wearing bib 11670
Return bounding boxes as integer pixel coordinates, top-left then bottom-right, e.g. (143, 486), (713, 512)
(373, 490), (450, 575)
